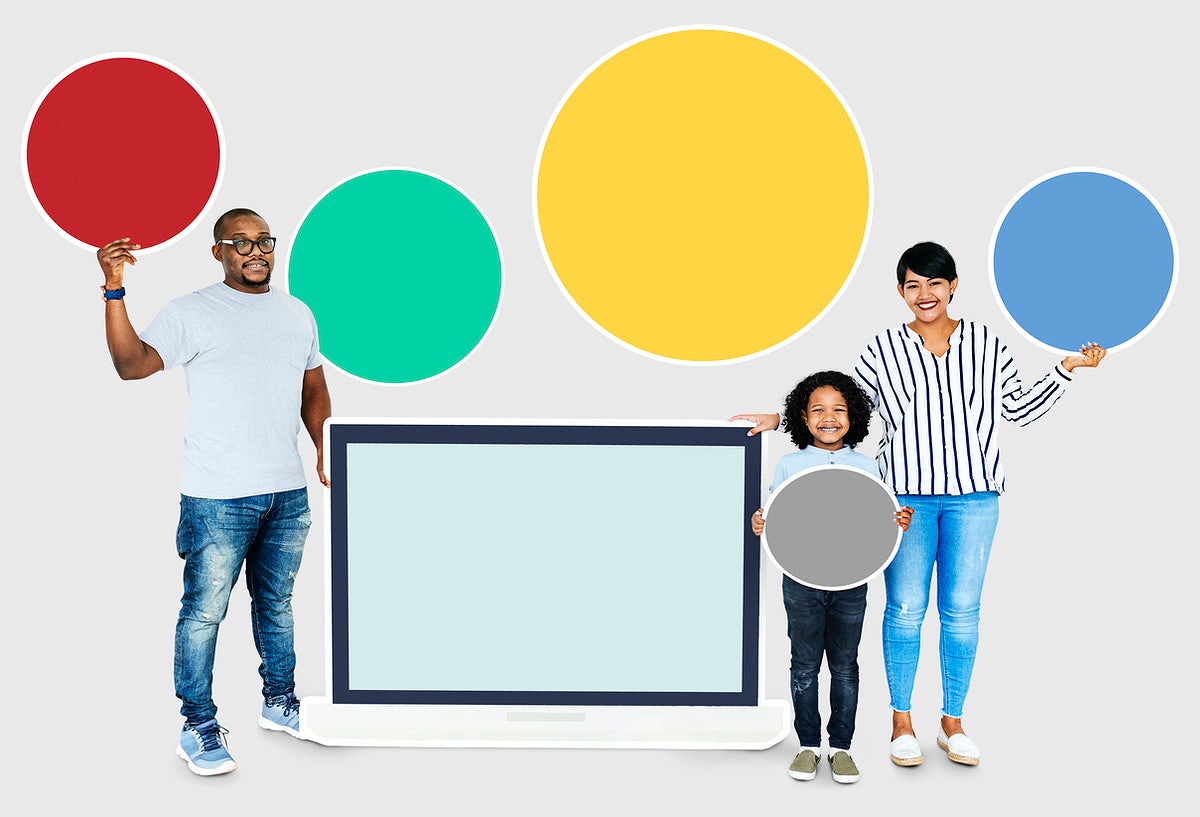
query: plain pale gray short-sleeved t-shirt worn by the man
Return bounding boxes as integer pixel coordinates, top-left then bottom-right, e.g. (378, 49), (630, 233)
(140, 282), (322, 499)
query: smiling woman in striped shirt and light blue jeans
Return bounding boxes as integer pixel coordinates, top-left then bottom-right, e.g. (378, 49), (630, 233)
(731, 241), (1106, 765)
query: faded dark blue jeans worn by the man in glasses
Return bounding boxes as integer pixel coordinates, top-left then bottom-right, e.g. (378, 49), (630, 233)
(175, 488), (312, 723)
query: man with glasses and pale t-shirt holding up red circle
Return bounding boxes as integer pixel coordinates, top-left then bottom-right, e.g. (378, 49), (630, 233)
(96, 209), (330, 775)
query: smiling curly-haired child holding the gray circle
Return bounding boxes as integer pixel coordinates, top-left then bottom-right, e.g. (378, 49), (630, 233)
(750, 372), (912, 783)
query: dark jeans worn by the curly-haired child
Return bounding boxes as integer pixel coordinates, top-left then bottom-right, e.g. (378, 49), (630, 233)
(784, 576), (866, 751)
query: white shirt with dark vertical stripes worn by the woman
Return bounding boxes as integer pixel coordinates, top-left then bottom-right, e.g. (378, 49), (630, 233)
(854, 320), (1072, 494)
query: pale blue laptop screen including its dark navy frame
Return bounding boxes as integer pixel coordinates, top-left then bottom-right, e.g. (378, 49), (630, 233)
(326, 419), (762, 705)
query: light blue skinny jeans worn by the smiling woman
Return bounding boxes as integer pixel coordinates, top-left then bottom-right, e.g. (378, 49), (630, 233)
(883, 492), (1000, 717)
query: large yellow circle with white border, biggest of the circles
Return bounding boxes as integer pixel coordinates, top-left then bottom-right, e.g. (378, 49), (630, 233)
(534, 28), (871, 362)
